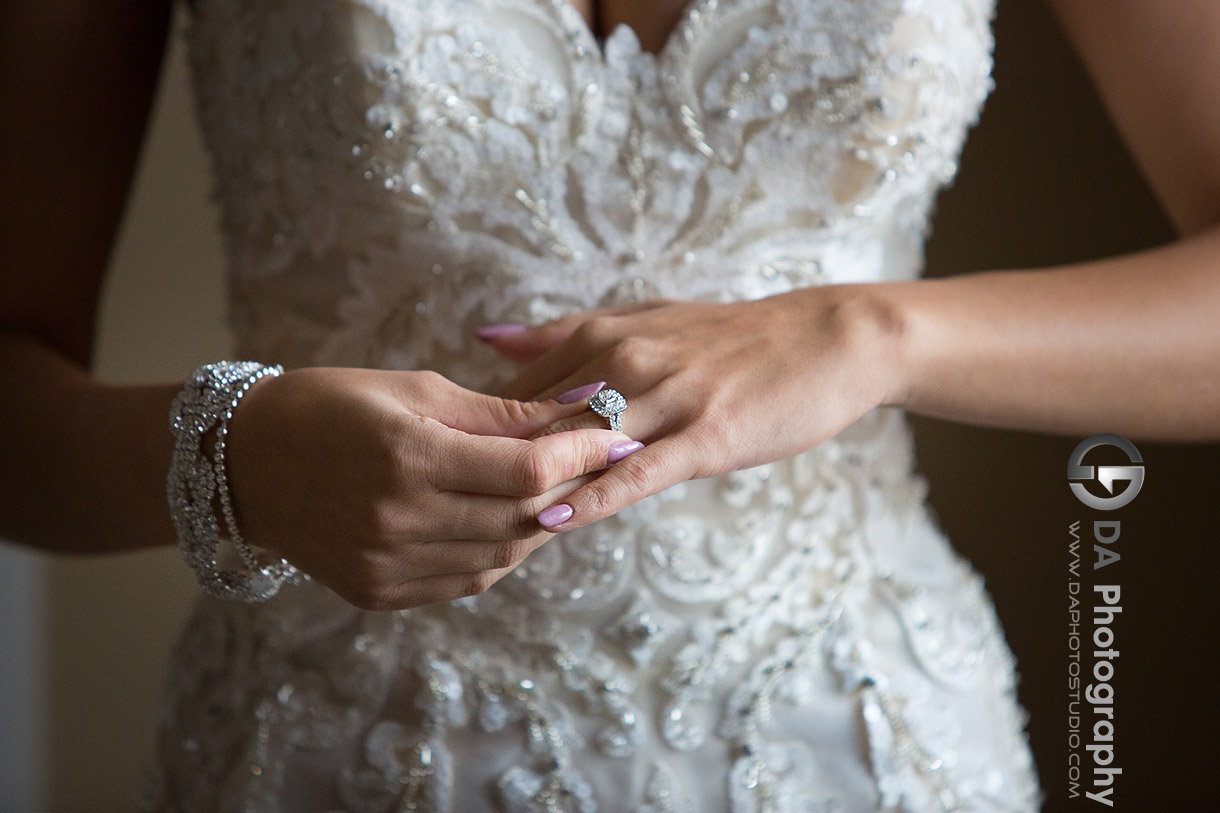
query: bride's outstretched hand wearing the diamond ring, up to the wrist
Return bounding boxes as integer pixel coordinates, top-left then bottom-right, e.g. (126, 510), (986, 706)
(481, 284), (903, 531)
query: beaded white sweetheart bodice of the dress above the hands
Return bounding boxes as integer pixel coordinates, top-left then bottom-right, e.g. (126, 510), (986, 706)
(192, 0), (991, 387)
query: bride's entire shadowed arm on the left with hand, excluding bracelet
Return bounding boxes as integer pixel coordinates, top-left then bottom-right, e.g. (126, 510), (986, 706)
(0, 0), (638, 609)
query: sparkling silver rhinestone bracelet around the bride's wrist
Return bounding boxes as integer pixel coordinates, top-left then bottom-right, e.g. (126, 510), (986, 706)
(166, 361), (309, 602)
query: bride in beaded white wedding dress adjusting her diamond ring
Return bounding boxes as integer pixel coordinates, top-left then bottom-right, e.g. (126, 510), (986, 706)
(0, 0), (1220, 812)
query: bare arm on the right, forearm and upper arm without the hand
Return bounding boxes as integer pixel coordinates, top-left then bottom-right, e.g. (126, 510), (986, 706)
(877, 0), (1220, 441)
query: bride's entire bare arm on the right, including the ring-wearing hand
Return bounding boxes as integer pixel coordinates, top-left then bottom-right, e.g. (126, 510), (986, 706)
(478, 0), (1220, 531)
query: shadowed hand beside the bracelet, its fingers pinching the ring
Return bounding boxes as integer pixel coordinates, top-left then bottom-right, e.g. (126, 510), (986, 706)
(226, 367), (628, 609)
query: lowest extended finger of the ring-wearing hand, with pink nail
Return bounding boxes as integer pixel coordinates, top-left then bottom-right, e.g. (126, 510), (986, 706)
(538, 437), (698, 533)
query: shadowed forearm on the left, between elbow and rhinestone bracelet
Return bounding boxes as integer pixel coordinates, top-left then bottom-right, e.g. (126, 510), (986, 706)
(0, 333), (182, 553)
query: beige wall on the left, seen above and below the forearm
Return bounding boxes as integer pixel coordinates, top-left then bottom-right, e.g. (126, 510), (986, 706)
(37, 7), (229, 813)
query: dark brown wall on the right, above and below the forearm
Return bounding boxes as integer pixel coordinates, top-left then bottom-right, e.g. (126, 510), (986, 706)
(914, 1), (1220, 813)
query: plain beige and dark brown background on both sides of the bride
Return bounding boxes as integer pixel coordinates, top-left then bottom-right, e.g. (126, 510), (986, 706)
(0, 2), (1220, 812)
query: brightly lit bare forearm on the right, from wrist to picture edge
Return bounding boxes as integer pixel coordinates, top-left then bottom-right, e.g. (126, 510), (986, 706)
(870, 223), (1220, 441)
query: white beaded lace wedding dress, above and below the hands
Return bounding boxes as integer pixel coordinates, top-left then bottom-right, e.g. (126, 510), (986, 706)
(144, 0), (1038, 813)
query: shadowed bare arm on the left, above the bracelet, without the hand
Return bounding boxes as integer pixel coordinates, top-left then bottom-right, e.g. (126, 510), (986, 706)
(0, 0), (176, 551)
